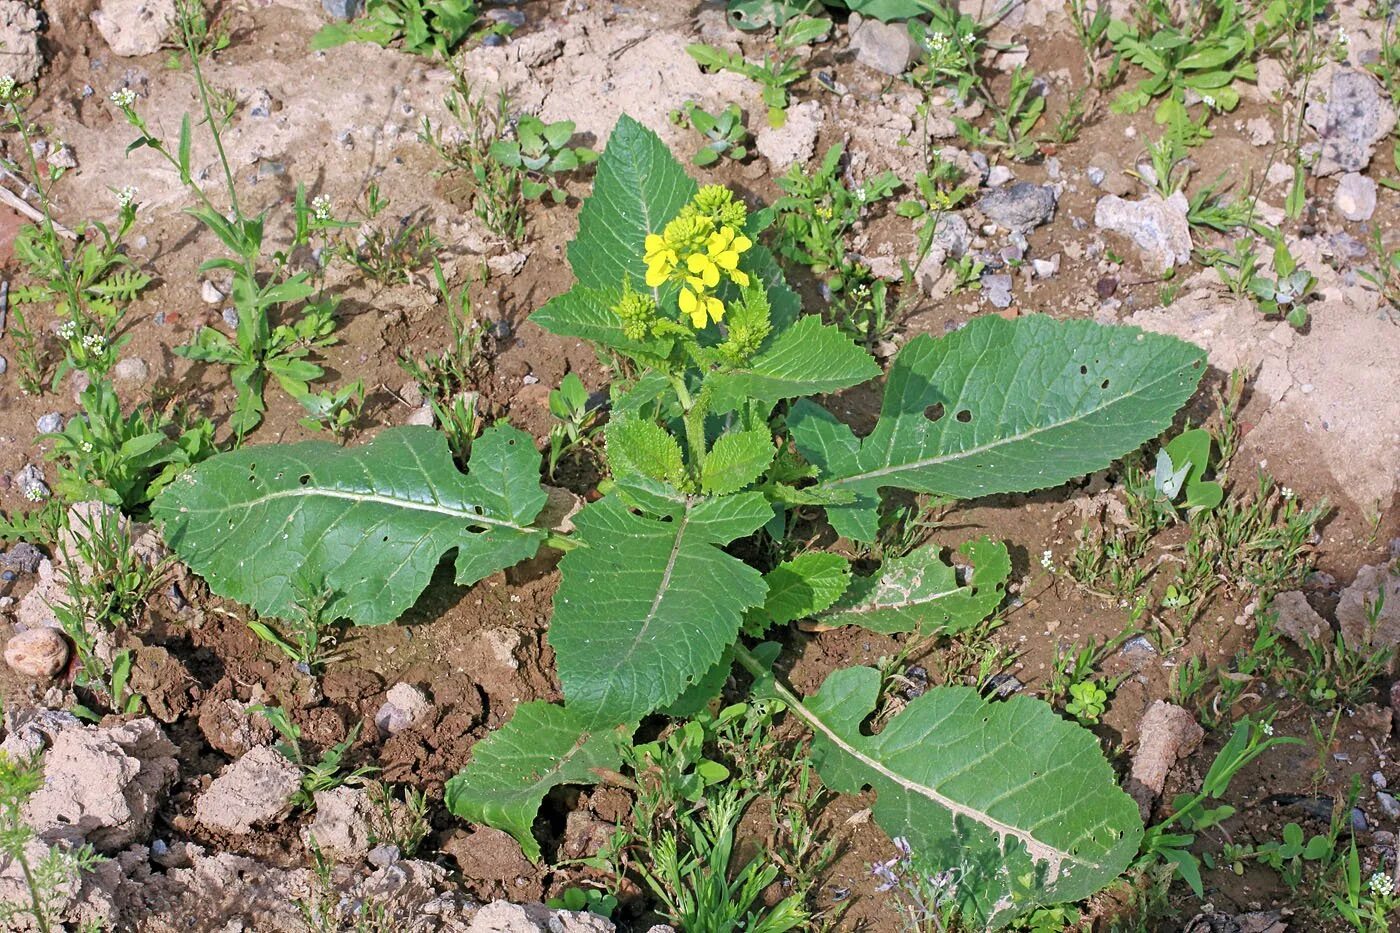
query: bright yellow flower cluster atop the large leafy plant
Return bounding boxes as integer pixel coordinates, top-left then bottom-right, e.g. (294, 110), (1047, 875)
(643, 185), (753, 329)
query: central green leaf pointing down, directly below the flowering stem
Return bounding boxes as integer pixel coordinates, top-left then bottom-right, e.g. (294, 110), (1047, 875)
(549, 492), (773, 728)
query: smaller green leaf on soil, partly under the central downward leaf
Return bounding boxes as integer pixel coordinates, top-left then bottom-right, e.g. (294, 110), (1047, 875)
(444, 700), (622, 862)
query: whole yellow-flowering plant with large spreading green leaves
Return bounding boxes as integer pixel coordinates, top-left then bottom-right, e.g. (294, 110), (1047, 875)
(153, 118), (1204, 929)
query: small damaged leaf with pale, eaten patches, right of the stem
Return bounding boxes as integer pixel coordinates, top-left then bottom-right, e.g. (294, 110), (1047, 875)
(815, 538), (1011, 635)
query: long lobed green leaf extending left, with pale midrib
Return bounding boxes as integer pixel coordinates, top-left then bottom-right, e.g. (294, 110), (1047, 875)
(151, 426), (545, 625)
